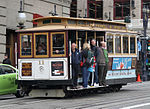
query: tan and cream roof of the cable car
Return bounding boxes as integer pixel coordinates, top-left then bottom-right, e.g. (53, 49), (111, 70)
(16, 16), (136, 33)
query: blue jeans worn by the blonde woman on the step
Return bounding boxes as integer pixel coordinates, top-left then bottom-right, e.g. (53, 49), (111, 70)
(82, 67), (90, 87)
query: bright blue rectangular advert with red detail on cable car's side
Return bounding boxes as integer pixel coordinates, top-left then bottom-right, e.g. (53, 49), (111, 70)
(112, 58), (132, 70)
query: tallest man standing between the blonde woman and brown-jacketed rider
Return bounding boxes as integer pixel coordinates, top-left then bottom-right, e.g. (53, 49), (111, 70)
(91, 39), (100, 86)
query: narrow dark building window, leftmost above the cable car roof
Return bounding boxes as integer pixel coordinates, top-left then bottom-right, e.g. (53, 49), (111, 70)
(70, 0), (77, 17)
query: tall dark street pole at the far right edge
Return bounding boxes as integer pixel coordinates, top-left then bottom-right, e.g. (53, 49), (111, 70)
(142, 7), (149, 81)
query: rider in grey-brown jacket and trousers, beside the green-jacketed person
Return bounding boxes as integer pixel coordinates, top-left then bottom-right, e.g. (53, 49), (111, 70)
(98, 43), (106, 86)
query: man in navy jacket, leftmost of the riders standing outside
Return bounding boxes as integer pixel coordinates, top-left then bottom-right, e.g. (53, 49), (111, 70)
(70, 43), (81, 89)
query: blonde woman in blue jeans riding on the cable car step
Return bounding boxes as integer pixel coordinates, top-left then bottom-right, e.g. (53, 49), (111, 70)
(82, 43), (93, 88)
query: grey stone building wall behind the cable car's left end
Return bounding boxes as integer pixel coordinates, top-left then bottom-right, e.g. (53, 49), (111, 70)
(0, 0), (71, 66)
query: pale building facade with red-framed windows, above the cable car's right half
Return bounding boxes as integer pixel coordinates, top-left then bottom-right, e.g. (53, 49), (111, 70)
(70, 0), (150, 35)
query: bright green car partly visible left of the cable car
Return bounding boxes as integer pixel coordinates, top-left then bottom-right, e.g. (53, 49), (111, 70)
(0, 64), (25, 98)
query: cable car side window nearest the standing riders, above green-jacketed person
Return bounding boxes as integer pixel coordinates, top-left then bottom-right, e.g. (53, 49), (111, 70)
(107, 35), (113, 53)
